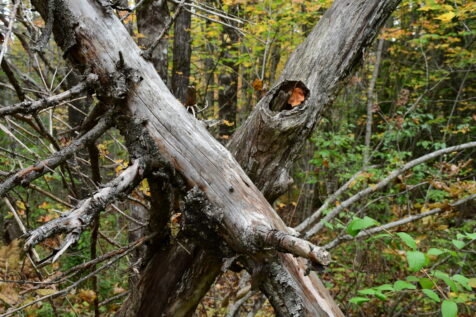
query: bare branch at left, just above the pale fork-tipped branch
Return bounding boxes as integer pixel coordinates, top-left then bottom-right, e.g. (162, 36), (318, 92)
(0, 113), (112, 197)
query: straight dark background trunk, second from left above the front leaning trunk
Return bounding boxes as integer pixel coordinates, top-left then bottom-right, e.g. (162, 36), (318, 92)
(170, 0), (192, 104)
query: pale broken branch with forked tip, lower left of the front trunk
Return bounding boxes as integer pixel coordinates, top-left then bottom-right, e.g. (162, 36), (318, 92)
(24, 159), (147, 262)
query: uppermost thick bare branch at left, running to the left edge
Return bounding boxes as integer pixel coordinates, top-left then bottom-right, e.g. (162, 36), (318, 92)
(0, 74), (98, 118)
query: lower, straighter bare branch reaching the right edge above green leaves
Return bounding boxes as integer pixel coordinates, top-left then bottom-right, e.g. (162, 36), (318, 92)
(322, 194), (476, 249)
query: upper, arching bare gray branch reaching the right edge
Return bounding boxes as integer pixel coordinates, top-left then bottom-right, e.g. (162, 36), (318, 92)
(304, 142), (476, 239)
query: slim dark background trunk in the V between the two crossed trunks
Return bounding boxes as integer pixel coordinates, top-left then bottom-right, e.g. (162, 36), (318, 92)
(218, 7), (239, 140)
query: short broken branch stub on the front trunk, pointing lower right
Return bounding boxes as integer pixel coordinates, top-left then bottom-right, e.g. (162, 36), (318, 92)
(257, 226), (331, 265)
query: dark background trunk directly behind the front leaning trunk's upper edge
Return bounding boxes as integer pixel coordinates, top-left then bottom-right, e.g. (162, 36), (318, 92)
(137, 0), (170, 83)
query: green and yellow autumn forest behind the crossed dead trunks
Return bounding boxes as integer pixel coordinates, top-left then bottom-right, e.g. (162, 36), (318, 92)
(0, 0), (476, 316)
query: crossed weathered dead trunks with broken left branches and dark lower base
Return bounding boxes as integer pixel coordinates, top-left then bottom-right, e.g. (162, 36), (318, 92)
(0, 0), (410, 316)
